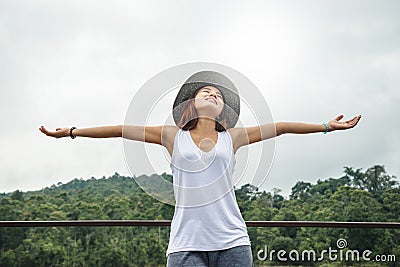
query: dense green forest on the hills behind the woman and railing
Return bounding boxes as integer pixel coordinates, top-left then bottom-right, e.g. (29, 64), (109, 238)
(0, 165), (400, 267)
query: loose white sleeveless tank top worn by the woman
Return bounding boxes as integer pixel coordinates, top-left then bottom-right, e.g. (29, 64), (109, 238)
(167, 129), (250, 256)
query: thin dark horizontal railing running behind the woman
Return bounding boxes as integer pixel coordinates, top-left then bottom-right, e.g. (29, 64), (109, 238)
(0, 220), (400, 229)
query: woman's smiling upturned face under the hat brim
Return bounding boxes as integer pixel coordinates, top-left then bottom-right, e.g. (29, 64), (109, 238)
(195, 85), (224, 119)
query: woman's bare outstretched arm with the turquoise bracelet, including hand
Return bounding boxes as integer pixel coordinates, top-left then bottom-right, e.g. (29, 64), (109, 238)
(229, 115), (361, 152)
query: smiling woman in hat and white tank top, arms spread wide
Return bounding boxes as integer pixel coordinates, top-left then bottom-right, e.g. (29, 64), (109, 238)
(40, 71), (361, 267)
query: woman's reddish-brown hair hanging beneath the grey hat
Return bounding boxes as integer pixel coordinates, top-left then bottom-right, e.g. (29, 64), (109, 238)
(178, 86), (227, 132)
